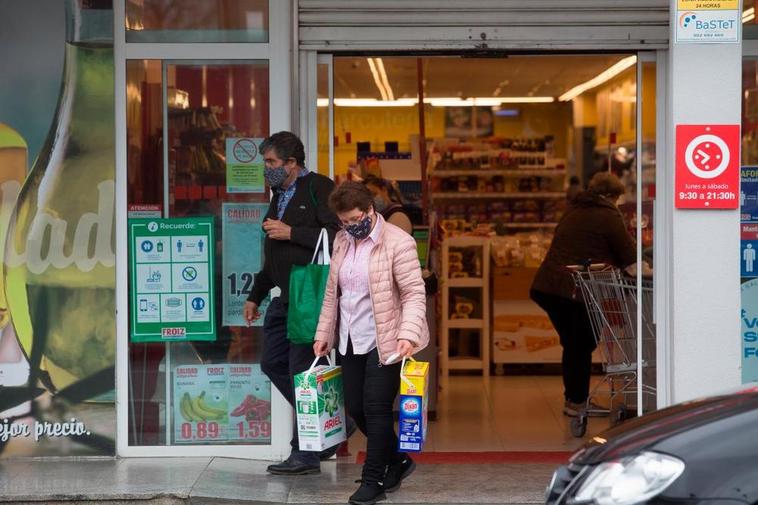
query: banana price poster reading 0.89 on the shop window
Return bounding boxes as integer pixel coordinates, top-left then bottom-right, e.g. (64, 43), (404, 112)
(173, 365), (229, 444)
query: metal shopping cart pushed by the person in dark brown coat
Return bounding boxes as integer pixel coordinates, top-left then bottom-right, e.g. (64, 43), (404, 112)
(569, 264), (655, 437)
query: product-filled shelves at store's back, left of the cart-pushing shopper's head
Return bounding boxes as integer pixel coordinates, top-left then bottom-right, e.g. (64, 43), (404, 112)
(429, 137), (566, 236)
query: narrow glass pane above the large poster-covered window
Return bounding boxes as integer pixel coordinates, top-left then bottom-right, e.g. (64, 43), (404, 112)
(126, 0), (269, 43)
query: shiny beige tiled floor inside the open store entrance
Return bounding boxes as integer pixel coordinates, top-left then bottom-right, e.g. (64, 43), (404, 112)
(350, 376), (609, 454)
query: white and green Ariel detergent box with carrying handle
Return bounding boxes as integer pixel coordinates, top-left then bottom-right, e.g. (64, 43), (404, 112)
(295, 361), (346, 451)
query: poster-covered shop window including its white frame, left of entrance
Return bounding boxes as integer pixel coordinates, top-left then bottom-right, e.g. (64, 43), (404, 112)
(116, 0), (292, 459)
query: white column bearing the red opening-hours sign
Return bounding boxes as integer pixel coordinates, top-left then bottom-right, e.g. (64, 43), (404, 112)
(668, 0), (742, 403)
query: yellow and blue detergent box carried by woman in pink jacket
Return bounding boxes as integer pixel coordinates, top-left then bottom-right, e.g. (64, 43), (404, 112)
(398, 361), (429, 452)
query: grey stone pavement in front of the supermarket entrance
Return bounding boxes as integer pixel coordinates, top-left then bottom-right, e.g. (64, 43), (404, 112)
(0, 458), (555, 505)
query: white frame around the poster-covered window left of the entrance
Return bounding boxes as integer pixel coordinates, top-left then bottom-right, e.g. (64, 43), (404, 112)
(113, 0), (293, 460)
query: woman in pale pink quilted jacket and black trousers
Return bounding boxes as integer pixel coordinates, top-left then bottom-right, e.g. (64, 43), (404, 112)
(313, 181), (429, 505)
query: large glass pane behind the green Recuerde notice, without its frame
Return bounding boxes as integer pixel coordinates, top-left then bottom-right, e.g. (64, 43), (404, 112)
(127, 60), (271, 446)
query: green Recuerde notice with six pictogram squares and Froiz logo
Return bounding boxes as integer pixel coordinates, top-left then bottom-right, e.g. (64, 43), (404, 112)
(129, 217), (216, 342)
